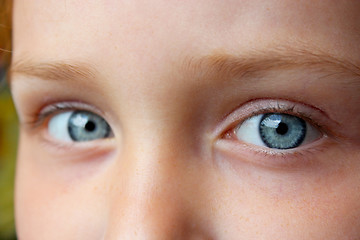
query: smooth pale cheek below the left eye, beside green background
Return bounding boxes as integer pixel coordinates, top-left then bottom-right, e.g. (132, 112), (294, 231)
(15, 136), (107, 239)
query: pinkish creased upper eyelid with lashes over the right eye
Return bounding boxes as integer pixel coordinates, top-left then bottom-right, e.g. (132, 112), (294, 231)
(213, 99), (339, 137)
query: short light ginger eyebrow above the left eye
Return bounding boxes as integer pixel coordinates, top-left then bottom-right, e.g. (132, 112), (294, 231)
(10, 60), (98, 81)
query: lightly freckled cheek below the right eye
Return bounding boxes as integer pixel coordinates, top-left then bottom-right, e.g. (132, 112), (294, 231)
(209, 148), (360, 240)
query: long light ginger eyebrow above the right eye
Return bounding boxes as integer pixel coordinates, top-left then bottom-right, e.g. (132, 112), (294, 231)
(182, 48), (360, 80)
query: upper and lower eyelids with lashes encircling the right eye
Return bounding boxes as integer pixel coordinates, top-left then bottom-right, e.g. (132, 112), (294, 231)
(211, 99), (332, 168)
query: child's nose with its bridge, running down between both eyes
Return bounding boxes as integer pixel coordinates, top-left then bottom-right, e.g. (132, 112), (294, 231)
(101, 83), (211, 240)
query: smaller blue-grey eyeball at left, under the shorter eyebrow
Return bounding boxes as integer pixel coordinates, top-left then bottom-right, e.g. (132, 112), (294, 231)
(48, 111), (112, 142)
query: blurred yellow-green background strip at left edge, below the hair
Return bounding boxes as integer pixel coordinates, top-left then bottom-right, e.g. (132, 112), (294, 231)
(0, 83), (18, 240)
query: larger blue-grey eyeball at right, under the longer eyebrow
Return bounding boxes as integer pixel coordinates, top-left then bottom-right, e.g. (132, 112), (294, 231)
(235, 113), (321, 149)
